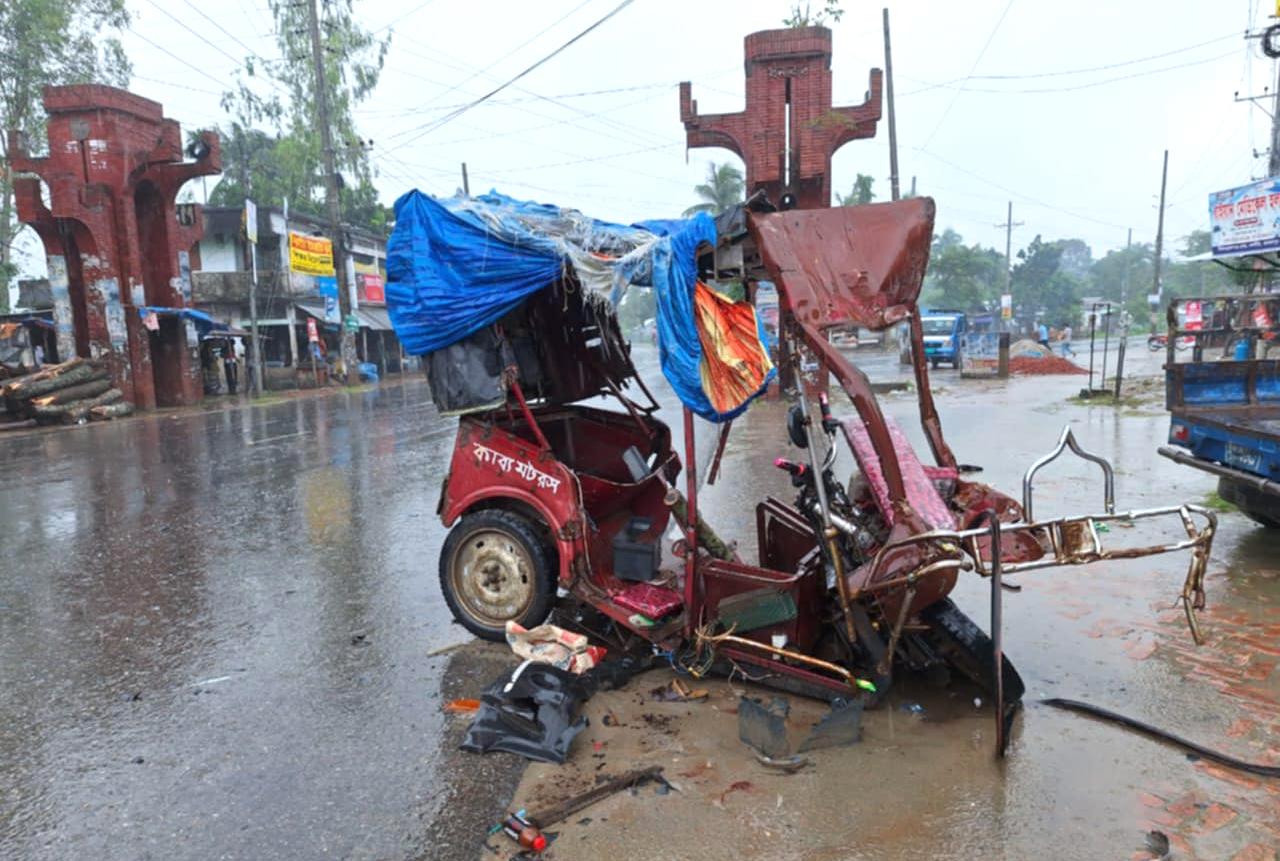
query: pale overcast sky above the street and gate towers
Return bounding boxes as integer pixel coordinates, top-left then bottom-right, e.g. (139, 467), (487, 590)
(10, 0), (1275, 275)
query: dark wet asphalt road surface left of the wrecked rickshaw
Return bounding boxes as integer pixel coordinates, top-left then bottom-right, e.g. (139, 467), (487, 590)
(0, 381), (488, 861)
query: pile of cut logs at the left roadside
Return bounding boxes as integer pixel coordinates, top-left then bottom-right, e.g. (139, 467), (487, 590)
(0, 358), (133, 430)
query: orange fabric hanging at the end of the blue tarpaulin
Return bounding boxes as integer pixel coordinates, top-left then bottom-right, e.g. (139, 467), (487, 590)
(694, 281), (773, 412)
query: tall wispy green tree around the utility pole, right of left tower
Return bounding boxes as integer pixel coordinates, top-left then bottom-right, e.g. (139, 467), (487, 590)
(211, 0), (390, 229)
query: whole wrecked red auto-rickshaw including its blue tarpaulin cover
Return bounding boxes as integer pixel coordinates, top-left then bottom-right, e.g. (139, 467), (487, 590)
(388, 192), (1216, 752)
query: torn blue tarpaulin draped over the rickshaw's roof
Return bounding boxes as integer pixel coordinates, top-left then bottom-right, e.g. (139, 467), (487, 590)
(387, 191), (774, 421)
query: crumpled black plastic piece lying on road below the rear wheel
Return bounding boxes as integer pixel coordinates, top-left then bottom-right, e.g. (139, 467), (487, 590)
(462, 661), (594, 764)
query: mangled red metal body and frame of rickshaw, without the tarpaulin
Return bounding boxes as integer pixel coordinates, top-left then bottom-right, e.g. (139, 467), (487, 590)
(427, 198), (1215, 736)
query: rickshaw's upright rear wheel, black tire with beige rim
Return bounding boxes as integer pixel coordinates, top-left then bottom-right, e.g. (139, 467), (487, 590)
(440, 509), (556, 642)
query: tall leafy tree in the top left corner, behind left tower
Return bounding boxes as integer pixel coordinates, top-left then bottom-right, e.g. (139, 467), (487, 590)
(0, 0), (129, 312)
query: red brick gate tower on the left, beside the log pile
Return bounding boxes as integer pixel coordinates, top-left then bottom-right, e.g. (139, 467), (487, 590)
(9, 84), (221, 409)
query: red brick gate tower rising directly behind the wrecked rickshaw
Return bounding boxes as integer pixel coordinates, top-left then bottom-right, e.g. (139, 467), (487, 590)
(680, 27), (881, 209)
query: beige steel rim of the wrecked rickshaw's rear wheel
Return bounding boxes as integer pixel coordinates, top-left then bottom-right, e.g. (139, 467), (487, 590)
(449, 530), (536, 628)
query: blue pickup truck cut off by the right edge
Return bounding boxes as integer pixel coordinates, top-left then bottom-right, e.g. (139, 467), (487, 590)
(1160, 293), (1280, 528)
